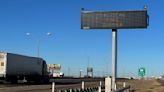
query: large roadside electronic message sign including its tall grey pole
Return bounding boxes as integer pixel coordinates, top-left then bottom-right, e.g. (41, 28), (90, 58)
(81, 8), (149, 92)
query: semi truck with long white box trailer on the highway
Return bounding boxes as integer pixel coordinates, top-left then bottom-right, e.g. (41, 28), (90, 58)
(0, 52), (49, 83)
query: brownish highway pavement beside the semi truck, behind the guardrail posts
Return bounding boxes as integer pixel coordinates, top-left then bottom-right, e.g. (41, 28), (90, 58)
(0, 79), (104, 92)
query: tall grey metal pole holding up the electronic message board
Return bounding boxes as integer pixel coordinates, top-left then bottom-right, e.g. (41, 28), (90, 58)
(112, 29), (117, 92)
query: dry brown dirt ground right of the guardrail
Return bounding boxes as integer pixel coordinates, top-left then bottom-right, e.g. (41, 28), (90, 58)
(123, 80), (164, 92)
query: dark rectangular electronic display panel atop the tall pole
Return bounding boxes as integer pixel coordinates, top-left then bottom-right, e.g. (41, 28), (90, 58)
(81, 10), (148, 29)
